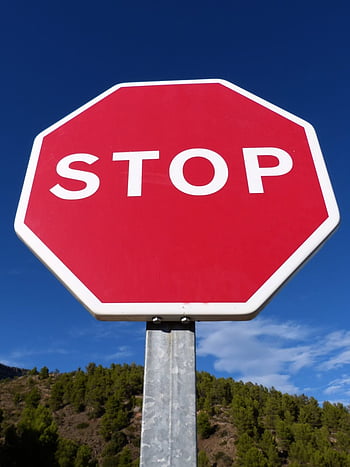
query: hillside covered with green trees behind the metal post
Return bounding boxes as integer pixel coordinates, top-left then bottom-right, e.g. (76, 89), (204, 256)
(0, 363), (350, 467)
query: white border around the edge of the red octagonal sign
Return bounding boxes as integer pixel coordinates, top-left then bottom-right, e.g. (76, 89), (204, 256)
(15, 79), (340, 321)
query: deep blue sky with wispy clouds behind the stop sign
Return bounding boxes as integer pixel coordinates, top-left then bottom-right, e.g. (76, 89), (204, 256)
(0, 0), (350, 404)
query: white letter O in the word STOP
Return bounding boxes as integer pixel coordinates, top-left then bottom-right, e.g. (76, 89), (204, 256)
(169, 148), (228, 196)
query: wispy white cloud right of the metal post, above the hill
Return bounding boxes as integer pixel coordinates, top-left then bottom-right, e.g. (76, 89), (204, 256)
(197, 318), (350, 396)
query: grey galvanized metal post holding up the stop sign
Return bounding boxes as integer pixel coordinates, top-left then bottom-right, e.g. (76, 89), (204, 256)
(140, 322), (197, 467)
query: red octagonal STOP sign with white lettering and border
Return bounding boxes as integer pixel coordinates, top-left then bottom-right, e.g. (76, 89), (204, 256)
(15, 80), (339, 320)
